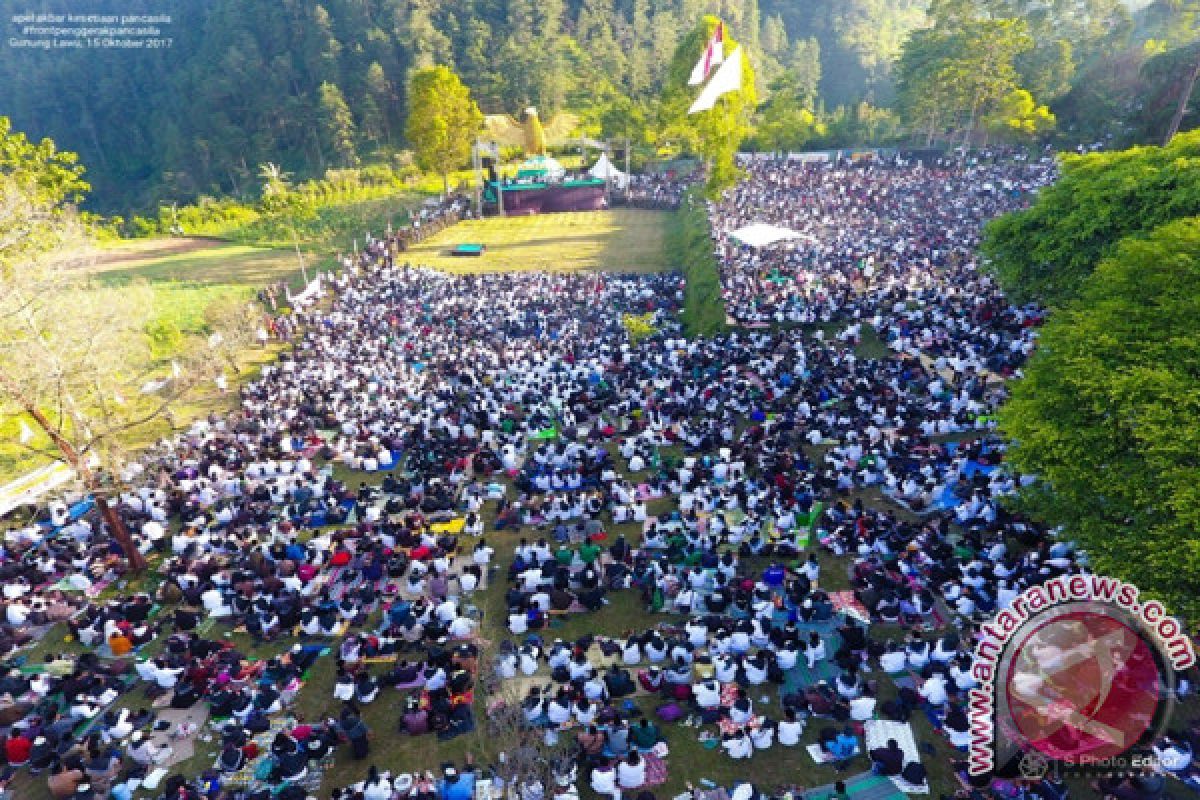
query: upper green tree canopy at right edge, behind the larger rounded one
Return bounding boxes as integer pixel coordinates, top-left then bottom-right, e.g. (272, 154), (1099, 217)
(983, 131), (1200, 306)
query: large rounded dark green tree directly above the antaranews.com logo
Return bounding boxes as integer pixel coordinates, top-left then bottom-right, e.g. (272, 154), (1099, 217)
(1000, 215), (1200, 622)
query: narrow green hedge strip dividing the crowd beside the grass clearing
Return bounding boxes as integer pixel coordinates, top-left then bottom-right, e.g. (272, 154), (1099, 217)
(666, 191), (727, 336)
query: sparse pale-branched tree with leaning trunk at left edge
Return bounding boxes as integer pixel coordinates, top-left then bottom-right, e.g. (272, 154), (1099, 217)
(0, 120), (241, 571)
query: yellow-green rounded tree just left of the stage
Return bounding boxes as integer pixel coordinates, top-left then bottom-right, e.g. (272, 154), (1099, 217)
(406, 66), (484, 192)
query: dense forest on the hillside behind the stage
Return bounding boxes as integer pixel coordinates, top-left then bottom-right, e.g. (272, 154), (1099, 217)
(0, 0), (1195, 211)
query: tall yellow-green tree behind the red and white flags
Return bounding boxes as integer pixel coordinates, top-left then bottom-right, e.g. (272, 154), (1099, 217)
(659, 16), (758, 196)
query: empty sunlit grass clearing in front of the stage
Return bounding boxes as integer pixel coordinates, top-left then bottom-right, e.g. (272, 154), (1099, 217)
(406, 209), (676, 272)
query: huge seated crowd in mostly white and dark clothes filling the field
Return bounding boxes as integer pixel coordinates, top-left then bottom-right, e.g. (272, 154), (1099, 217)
(0, 158), (1200, 800)
